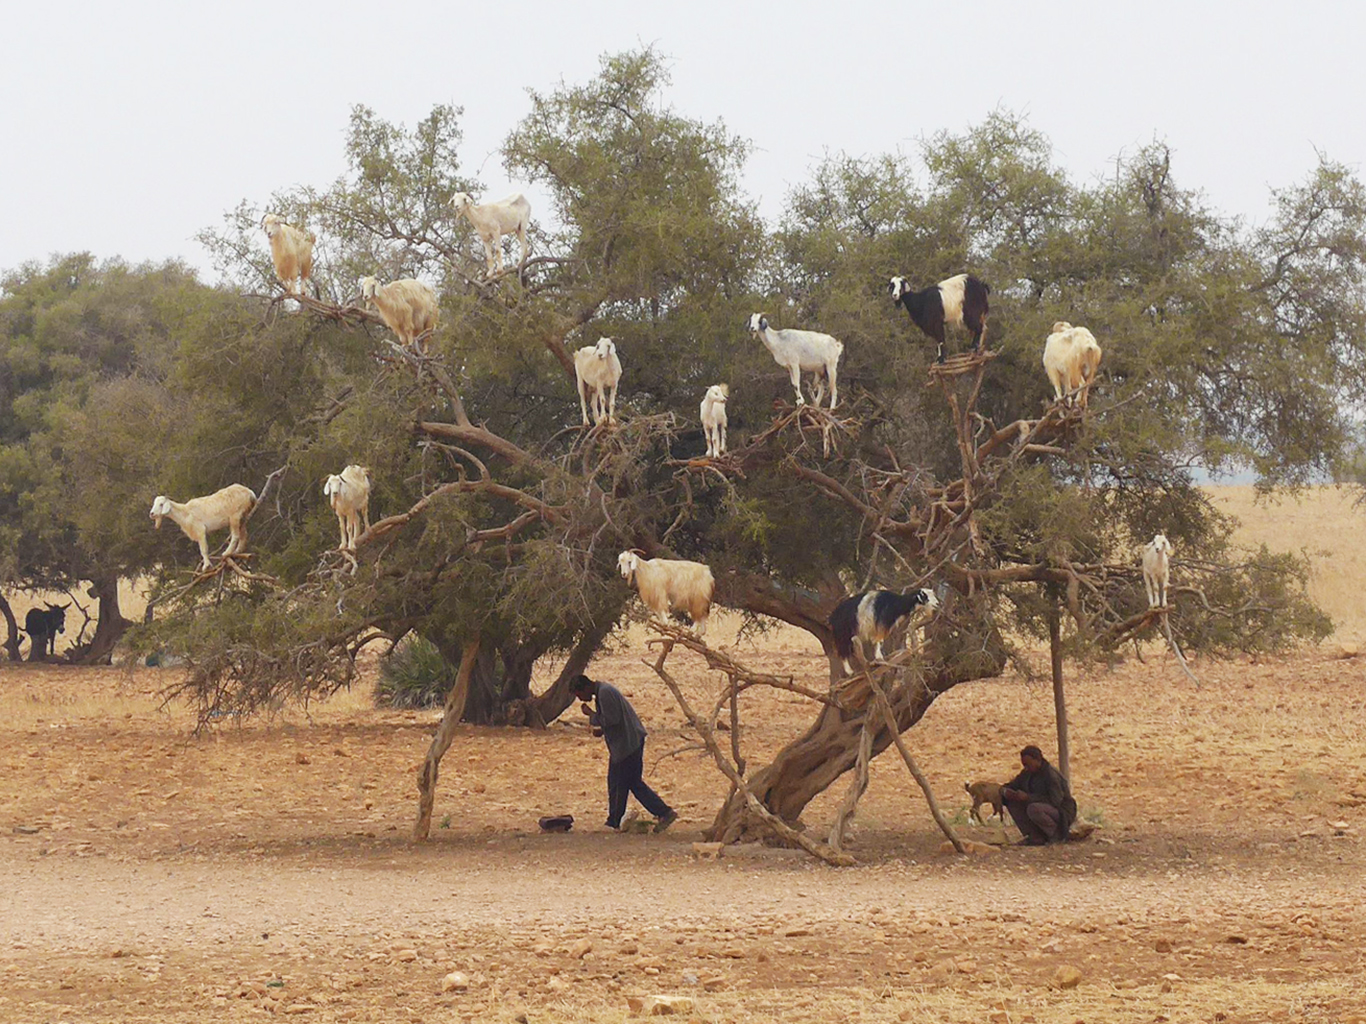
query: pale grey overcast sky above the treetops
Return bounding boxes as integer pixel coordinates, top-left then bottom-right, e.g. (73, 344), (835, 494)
(0, 0), (1366, 278)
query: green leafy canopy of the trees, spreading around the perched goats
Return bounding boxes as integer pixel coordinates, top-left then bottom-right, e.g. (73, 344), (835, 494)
(0, 49), (1366, 835)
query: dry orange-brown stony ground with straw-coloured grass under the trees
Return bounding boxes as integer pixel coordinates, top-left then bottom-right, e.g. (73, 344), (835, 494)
(0, 489), (1366, 1024)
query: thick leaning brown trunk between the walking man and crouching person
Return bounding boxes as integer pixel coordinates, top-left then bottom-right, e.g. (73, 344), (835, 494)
(706, 617), (1005, 842)
